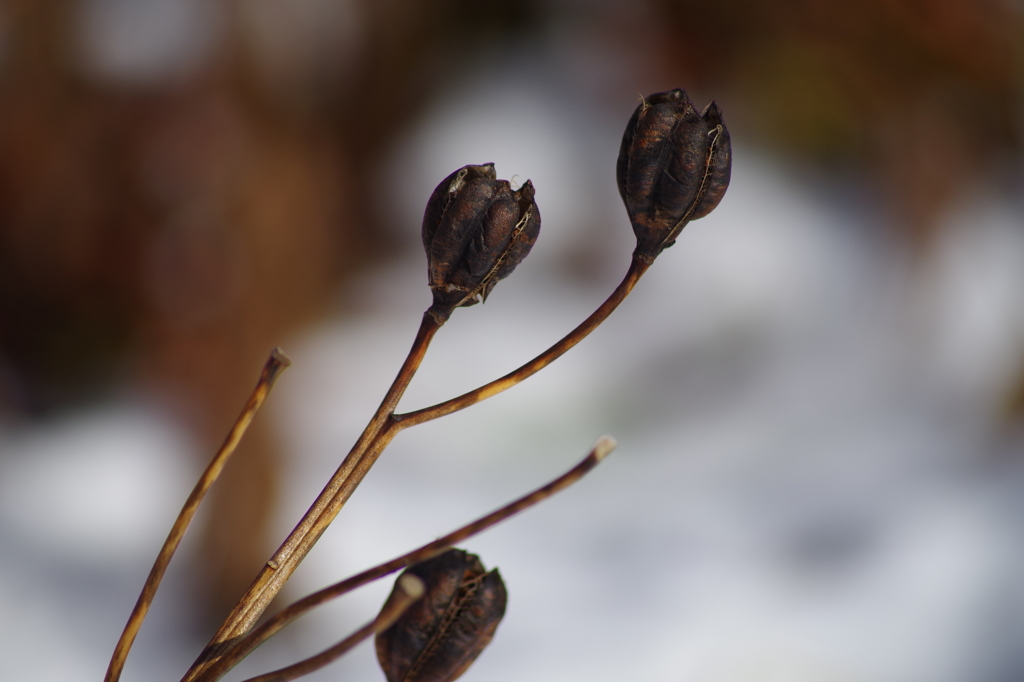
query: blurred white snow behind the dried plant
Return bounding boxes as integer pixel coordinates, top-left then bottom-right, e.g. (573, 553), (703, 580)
(0, 1), (1024, 682)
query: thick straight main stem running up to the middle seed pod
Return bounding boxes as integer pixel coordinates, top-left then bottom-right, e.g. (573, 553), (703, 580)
(182, 313), (440, 682)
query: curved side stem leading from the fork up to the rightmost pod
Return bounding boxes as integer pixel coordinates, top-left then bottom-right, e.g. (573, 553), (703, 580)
(392, 254), (650, 429)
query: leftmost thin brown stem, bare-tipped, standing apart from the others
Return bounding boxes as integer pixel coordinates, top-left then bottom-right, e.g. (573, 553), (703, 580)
(103, 348), (292, 682)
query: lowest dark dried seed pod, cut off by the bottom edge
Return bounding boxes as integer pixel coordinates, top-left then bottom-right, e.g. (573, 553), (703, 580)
(377, 549), (506, 682)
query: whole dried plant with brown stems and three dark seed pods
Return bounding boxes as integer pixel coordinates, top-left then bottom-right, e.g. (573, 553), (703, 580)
(104, 89), (731, 682)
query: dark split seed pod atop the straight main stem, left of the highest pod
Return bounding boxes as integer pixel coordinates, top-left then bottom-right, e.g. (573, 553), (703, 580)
(423, 164), (541, 322)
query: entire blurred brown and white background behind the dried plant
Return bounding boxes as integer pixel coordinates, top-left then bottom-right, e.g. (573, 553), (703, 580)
(0, 0), (1024, 682)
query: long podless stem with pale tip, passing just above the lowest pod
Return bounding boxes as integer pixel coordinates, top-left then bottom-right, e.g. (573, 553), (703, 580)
(202, 436), (615, 682)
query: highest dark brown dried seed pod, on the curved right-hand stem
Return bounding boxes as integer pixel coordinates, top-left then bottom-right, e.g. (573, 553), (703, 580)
(615, 89), (732, 262)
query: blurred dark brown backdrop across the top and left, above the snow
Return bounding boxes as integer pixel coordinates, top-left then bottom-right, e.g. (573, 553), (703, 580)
(0, 0), (1024, 617)
